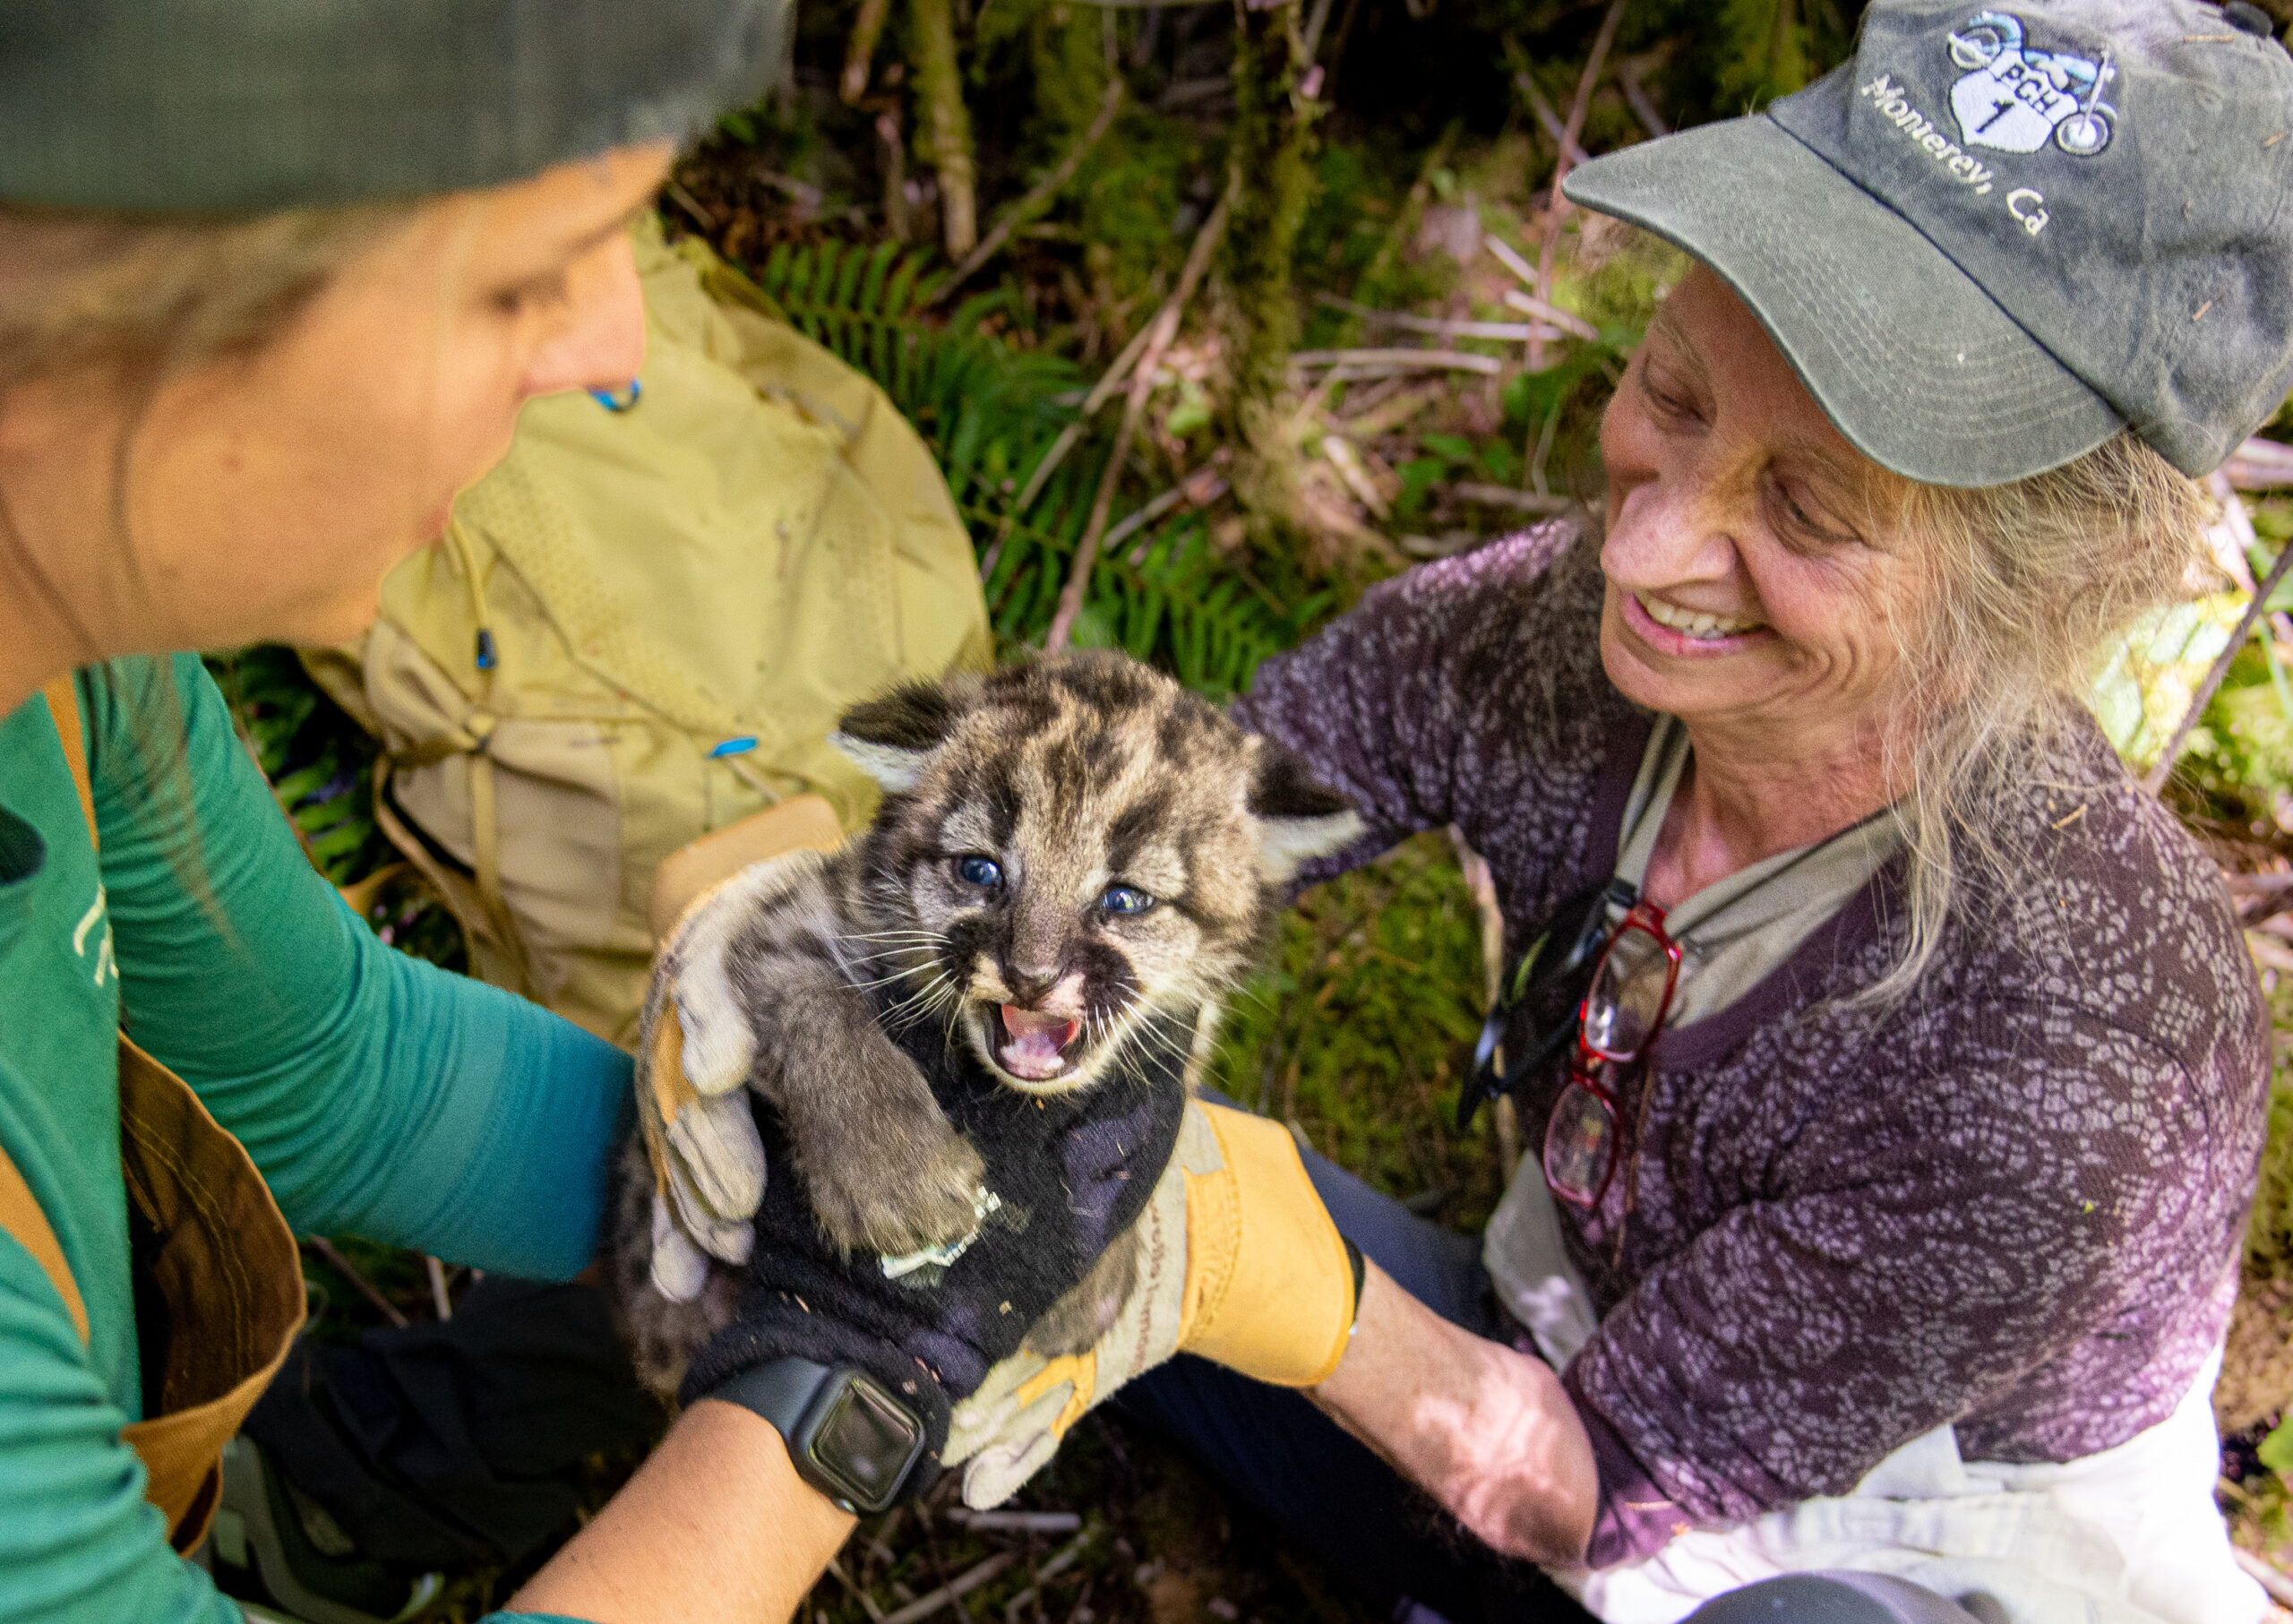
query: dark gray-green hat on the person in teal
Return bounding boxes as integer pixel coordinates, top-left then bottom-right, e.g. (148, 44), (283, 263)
(0, 0), (794, 213)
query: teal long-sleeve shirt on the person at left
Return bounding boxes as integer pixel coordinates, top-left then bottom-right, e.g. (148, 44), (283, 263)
(0, 656), (628, 1624)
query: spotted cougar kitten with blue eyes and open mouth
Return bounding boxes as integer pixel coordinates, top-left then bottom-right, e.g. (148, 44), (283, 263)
(613, 654), (1362, 1392)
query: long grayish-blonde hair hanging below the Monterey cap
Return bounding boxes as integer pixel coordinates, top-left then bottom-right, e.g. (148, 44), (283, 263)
(1858, 431), (2215, 1005)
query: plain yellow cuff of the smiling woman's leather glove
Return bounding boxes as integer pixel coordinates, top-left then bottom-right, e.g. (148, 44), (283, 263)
(1179, 1104), (1355, 1388)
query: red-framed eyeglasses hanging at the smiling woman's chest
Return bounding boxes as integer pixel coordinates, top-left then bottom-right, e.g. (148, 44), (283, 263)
(1545, 901), (1680, 1207)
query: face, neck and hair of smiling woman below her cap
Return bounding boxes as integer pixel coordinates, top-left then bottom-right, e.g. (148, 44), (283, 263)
(1601, 266), (2212, 1002)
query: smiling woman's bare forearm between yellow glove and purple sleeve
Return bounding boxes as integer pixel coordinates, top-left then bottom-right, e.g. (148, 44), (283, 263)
(1310, 1264), (1601, 1564)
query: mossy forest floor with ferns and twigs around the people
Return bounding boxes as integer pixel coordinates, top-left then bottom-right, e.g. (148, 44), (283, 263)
(213, 0), (2293, 1624)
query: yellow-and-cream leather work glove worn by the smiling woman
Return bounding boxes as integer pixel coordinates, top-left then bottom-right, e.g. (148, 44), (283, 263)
(947, 1101), (1362, 1509)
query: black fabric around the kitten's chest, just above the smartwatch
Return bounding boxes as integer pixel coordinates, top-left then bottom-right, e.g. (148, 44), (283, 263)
(681, 1027), (1186, 1489)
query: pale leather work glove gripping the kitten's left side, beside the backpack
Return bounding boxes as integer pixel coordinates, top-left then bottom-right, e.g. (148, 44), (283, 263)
(638, 796), (844, 1302)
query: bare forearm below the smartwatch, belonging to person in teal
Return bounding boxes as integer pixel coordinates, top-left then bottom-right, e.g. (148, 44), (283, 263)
(509, 1399), (853, 1624)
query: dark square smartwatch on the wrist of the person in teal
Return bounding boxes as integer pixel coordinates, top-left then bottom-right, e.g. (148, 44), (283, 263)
(709, 1355), (924, 1517)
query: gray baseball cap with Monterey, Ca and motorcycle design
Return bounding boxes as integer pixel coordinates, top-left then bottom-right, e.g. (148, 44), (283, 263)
(1564, 0), (2293, 486)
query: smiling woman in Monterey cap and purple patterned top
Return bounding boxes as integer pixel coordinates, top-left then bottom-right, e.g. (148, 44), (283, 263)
(903, 0), (2293, 1624)
